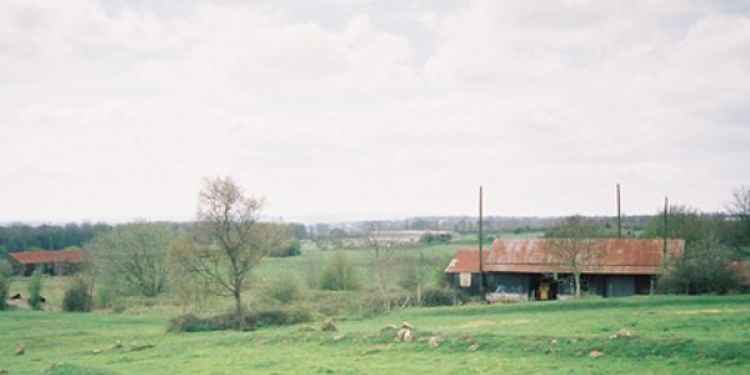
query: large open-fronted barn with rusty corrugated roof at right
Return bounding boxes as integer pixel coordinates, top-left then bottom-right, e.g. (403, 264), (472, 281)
(445, 239), (685, 301)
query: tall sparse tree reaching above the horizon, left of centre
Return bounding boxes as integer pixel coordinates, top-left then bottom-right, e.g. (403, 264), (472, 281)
(171, 177), (288, 328)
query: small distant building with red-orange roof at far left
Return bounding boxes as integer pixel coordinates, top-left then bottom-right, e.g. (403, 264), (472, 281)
(8, 250), (86, 276)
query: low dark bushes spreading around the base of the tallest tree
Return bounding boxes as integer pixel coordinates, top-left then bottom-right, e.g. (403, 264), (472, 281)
(167, 306), (313, 332)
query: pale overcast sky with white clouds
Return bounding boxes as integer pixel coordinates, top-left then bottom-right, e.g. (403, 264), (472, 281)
(0, 0), (750, 222)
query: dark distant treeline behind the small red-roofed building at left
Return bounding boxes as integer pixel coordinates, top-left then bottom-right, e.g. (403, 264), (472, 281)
(0, 223), (112, 254)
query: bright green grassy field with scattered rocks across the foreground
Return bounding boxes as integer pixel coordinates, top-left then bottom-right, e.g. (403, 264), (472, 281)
(0, 296), (750, 375)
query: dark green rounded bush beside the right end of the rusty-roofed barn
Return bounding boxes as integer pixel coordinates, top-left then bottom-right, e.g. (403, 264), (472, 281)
(657, 238), (742, 294)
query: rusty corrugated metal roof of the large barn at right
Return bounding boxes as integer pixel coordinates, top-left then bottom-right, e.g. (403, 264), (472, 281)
(445, 239), (685, 275)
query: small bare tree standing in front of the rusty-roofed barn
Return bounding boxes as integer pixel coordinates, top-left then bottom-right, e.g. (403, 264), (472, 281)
(545, 216), (599, 297)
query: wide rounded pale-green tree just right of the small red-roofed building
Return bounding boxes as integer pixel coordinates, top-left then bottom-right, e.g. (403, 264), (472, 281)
(87, 222), (174, 297)
